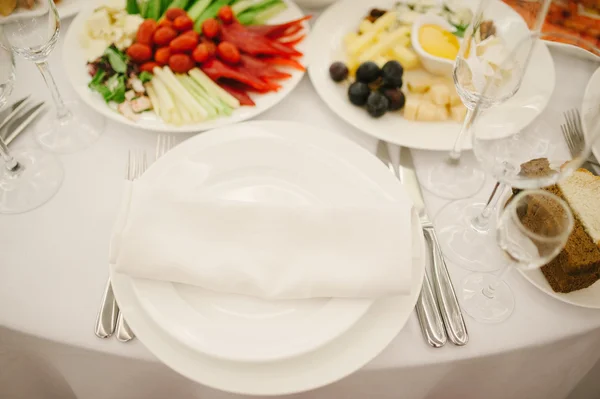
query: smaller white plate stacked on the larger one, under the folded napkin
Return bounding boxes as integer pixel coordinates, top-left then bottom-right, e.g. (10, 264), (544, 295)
(133, 122), (420, 362)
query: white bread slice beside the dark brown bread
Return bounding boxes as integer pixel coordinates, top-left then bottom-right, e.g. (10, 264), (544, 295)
(558, 169), (600, 246)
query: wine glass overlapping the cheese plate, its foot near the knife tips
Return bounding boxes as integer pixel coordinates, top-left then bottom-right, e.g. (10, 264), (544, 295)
(423, 0), (551, 199)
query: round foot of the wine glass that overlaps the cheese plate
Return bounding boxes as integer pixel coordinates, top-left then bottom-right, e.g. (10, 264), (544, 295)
(423, 161), (485, 200)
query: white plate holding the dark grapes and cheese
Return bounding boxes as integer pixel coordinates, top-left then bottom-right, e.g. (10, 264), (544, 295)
(308, 0), (554, 150)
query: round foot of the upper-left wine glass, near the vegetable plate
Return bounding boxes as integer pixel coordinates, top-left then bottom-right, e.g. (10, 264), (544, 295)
(36, 101), (105, 154)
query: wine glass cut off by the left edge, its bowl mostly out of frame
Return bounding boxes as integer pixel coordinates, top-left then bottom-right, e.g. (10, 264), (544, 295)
(0, 26), (63, 213)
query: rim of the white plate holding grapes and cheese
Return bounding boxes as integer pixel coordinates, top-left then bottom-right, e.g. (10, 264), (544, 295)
(308, 0), (552, 151)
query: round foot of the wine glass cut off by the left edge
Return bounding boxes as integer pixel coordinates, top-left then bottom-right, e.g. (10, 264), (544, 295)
(0, 149), (64, 214)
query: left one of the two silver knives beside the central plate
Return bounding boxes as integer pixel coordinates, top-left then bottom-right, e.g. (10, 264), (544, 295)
(377, 141), (448, 348)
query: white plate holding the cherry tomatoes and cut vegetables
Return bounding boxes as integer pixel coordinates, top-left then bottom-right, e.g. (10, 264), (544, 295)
(63, 0), (309, 133)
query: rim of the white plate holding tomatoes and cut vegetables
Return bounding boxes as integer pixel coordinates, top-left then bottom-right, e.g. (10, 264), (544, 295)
(61, 0), (311, 134)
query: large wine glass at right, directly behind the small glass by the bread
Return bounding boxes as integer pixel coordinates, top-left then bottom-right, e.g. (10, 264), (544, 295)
(433, 33), (600, 272)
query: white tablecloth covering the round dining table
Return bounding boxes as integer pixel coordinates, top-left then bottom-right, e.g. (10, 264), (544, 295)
(0, 12), (600, 399)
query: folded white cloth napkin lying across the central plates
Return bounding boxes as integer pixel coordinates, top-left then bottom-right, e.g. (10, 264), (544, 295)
(110, 181), (412, 299)
